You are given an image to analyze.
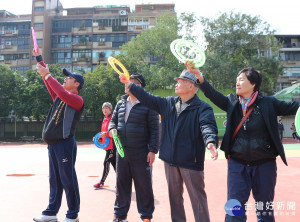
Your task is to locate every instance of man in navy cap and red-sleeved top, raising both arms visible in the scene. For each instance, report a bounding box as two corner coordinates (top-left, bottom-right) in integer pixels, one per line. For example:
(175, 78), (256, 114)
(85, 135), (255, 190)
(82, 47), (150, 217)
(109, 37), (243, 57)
(33, 50), (84, 222)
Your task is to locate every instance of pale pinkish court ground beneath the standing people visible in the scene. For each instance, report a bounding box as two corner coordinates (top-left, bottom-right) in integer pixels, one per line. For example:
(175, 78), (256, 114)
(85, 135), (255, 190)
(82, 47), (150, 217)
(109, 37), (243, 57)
(0, 140), (300, 222)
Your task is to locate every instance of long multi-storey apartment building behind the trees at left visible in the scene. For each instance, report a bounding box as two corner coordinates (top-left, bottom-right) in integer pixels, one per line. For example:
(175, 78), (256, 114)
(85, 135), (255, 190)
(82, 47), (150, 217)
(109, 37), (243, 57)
(0, 0), (176, 73)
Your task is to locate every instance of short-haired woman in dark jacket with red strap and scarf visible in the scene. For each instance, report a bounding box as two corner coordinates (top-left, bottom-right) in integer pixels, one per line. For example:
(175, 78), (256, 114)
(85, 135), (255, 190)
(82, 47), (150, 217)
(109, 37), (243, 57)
(185, 62), (299, 222)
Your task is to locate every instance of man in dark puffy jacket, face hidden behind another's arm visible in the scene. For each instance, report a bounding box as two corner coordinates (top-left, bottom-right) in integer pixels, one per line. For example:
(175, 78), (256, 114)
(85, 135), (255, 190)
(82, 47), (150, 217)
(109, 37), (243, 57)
(108, 74), (159, 222)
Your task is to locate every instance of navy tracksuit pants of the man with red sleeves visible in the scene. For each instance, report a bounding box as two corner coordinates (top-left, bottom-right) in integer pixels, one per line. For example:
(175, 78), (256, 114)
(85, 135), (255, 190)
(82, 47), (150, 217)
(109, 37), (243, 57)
(42, 137), (80, 219)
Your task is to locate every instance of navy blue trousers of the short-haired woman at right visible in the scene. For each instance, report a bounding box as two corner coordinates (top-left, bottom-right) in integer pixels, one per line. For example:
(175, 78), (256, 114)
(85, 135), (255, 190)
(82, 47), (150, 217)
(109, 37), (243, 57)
(225, 159), (277, 222)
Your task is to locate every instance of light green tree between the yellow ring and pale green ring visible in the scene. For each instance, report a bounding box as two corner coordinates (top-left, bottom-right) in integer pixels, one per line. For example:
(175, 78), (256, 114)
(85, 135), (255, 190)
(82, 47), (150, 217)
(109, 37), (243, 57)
(121, 13), (184, 90)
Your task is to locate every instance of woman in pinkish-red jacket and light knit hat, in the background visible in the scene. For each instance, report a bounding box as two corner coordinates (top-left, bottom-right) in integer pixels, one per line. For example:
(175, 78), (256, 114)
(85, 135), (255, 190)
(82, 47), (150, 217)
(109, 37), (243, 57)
(94, 102), (116, 189)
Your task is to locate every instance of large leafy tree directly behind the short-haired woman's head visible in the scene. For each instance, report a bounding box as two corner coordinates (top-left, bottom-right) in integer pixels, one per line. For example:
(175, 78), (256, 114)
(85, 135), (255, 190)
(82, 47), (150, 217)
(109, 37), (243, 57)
(200, 11), (282, 93)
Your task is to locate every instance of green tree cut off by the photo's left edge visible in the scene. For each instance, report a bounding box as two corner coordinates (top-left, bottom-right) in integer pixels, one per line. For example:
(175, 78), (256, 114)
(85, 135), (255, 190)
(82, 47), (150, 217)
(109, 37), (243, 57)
(0, 65), (16, 117)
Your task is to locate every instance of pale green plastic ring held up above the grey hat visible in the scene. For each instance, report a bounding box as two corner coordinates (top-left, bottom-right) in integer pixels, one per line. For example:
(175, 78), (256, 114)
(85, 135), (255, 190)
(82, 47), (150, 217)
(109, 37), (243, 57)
(170, 39), (206, 68)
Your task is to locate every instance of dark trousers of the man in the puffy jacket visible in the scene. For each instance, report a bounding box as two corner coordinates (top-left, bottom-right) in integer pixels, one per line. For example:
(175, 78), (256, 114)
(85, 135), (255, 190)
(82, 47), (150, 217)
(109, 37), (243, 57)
(114, 147), (154, 219)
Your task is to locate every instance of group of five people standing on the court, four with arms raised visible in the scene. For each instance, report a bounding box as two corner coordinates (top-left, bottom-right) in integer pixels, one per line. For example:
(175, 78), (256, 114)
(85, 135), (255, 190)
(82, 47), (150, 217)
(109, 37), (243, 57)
(34, 48), (299, 222)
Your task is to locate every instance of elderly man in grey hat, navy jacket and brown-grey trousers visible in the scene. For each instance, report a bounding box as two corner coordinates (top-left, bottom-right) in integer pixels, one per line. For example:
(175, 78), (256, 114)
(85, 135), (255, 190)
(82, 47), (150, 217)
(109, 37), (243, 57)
(120, 70), (218, 222)
